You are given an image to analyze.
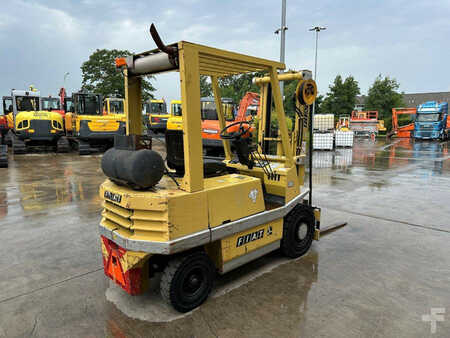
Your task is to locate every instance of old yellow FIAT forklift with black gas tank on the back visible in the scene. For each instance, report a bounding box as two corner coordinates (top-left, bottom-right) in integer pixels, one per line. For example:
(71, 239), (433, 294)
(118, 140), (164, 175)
(99, 25), (320, 312)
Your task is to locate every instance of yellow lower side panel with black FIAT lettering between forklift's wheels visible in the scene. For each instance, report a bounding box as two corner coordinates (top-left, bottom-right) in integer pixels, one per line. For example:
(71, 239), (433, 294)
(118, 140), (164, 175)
(220, 218), (283, 263)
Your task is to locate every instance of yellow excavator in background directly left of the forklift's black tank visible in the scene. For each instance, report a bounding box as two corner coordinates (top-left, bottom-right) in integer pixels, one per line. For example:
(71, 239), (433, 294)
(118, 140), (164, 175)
(65, 92), (125, 155)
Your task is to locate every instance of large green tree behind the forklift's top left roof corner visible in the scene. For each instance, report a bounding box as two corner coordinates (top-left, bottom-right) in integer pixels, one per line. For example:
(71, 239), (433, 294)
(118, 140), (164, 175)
(81, 49), (155, 101)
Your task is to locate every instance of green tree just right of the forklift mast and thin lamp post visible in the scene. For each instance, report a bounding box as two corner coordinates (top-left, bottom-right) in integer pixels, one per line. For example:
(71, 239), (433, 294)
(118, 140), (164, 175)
(320, 75), (360, 115)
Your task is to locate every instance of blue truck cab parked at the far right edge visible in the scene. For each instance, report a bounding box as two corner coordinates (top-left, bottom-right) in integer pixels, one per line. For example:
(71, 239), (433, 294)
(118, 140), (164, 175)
(414, 101), (448, 140)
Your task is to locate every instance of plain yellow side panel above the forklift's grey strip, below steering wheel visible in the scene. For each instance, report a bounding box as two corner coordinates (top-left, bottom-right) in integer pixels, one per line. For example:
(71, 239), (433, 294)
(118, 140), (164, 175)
(205, 174), (265, 227)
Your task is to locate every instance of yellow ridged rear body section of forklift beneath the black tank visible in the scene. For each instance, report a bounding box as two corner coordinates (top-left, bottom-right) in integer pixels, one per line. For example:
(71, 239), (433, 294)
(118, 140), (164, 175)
(100, 177), (208, 242)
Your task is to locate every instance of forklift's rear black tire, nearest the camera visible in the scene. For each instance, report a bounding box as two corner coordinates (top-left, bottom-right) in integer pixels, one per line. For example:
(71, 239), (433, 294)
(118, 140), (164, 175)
(160, 251), (215, 312)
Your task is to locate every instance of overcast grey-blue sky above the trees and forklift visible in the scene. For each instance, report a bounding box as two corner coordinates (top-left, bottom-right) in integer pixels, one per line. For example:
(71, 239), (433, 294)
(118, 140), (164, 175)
(0, 0), (450, 109)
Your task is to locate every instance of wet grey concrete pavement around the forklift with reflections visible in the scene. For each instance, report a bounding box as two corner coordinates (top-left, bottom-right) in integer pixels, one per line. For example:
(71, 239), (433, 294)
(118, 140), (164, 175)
(0, 140), (450, 337)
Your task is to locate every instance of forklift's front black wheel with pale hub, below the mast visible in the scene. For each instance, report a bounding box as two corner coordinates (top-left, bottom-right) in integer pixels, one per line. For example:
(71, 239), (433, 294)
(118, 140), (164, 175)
(281, 204), (315, 258)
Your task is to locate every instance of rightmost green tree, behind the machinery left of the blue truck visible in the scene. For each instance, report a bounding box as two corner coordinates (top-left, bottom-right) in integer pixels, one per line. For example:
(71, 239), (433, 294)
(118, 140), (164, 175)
(365, 74), (404, 129)
